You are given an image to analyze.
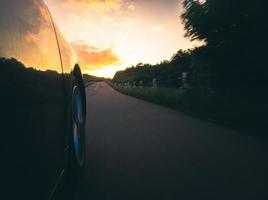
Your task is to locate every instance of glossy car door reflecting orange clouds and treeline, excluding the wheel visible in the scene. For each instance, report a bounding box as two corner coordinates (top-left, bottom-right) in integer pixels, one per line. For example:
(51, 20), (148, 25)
(0, 0), (66, 199)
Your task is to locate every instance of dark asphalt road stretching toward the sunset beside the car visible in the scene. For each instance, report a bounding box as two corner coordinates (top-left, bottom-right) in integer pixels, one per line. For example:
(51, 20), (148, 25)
(75, 83), (268, 200)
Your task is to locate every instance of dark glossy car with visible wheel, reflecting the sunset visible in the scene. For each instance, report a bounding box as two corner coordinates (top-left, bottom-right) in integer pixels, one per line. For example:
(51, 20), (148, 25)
(0, 0), (86, 200)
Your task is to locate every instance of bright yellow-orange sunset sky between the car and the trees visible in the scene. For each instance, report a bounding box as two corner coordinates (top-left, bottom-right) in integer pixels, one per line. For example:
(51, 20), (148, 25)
(45, 0), (197, 78)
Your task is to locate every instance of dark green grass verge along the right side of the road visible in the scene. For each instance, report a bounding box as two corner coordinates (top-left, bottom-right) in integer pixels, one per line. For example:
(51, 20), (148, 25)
(114, 84), (264, 134)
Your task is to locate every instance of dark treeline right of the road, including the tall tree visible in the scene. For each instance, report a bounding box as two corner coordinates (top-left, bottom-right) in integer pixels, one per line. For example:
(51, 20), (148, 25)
(113, 0), (268, 133)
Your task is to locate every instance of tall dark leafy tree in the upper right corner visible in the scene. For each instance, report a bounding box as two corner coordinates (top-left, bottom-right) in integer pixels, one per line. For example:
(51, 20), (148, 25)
(182, 0), (268, 93)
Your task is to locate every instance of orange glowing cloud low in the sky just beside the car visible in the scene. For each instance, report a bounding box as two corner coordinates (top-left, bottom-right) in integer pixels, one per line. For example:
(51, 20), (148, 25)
(72, 41), (121, 70)
